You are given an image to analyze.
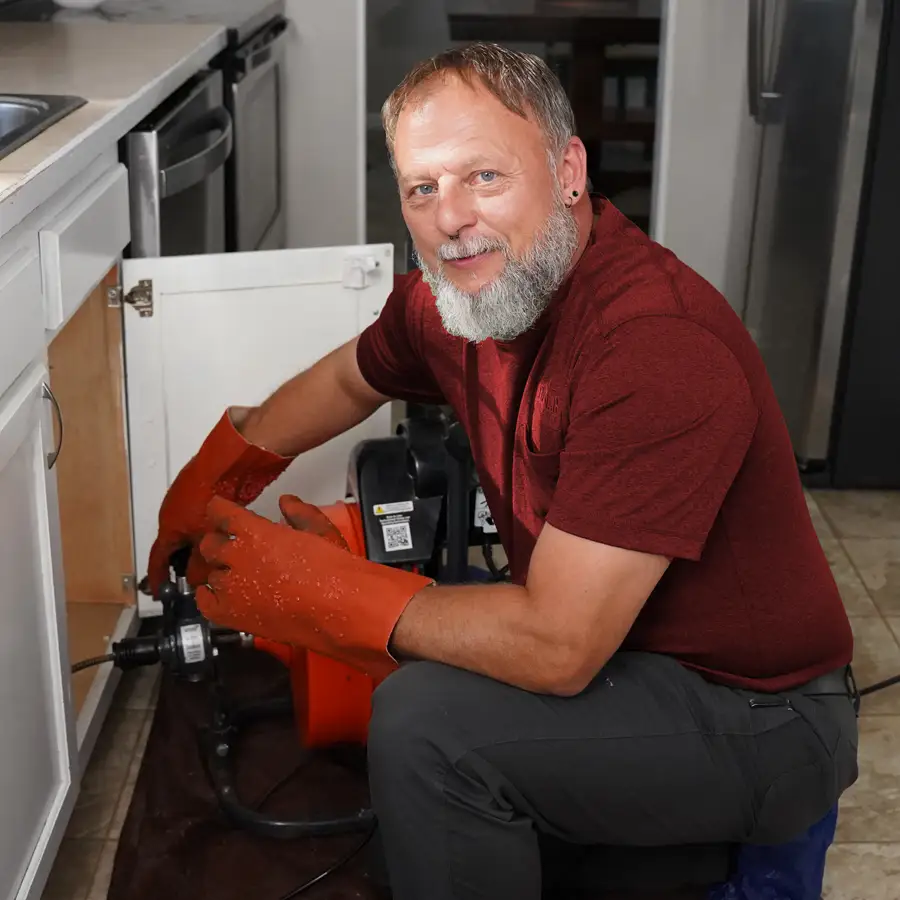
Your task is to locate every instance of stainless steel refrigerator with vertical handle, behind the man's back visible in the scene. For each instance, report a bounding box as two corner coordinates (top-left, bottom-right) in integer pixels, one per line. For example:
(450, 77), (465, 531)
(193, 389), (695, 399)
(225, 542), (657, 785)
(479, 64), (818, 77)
(741, 0), (885, 468)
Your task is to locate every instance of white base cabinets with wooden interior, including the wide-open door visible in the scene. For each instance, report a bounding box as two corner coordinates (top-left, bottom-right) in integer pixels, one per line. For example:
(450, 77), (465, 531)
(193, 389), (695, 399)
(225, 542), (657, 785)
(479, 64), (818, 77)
(0, 174), (394, 900)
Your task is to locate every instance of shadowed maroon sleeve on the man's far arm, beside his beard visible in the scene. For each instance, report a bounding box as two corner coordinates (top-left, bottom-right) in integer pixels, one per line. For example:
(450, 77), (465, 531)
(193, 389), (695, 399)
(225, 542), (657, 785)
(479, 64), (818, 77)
(356, 270), (446, 404)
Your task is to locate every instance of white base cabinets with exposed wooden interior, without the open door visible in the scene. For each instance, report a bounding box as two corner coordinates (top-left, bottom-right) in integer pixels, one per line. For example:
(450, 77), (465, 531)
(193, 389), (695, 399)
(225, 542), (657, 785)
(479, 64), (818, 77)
(0, 153), (137, 900)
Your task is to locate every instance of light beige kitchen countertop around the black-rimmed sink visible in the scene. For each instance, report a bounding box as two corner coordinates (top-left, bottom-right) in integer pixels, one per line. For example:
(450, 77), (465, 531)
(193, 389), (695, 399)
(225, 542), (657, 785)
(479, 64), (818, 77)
(0, 22), (226, 236)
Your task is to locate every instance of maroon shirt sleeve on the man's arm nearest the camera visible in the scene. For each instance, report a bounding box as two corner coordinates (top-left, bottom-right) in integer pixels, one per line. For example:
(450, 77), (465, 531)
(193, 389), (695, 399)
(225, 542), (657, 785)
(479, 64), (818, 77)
(546, 317), (757, 560)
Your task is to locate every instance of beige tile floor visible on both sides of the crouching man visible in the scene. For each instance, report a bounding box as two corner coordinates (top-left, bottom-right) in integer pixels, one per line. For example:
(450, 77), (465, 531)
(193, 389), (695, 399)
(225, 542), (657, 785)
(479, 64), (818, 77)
(44, 491), (900, 900)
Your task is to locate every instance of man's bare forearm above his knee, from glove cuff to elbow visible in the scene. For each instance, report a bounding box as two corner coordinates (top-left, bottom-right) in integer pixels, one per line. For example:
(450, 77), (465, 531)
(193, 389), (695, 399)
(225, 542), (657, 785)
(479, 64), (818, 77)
(390, 584), (592, 694)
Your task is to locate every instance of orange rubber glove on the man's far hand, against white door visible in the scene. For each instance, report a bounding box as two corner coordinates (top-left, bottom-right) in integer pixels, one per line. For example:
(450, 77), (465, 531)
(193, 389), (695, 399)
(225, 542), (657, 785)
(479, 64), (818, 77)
(147, 410), (293, 595)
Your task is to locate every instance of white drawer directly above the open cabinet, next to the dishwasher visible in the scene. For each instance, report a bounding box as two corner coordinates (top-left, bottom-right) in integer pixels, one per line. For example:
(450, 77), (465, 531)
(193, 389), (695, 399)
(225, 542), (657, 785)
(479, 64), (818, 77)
(39, 165), (131, 331)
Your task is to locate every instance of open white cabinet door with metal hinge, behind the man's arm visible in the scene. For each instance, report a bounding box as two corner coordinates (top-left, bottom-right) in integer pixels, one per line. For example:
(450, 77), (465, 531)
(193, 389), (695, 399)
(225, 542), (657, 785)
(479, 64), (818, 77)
(122, 244), (394, 616)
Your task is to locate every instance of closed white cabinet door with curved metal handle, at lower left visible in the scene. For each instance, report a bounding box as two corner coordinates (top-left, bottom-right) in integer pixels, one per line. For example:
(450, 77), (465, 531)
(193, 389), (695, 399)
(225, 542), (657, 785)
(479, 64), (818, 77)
(0, 365), (75, 900)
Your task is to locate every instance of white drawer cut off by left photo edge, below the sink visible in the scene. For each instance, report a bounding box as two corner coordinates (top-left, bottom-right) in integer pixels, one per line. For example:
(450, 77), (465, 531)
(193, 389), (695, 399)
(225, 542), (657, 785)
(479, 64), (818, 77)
(0, 243), (44, 396)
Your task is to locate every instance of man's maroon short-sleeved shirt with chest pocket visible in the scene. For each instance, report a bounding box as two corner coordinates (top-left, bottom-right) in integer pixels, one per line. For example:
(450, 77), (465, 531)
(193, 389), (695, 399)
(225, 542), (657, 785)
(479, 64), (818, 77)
(358, 200), (852, 690)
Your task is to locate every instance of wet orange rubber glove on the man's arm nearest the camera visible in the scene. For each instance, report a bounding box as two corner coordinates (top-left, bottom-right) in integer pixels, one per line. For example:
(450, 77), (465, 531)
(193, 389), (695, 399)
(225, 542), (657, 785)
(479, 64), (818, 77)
(196, 497), (433, 678)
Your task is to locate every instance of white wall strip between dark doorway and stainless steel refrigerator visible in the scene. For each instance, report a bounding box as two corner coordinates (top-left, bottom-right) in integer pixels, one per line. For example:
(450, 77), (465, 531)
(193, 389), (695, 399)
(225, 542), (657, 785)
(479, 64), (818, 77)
(652, 0), (760, 312)
